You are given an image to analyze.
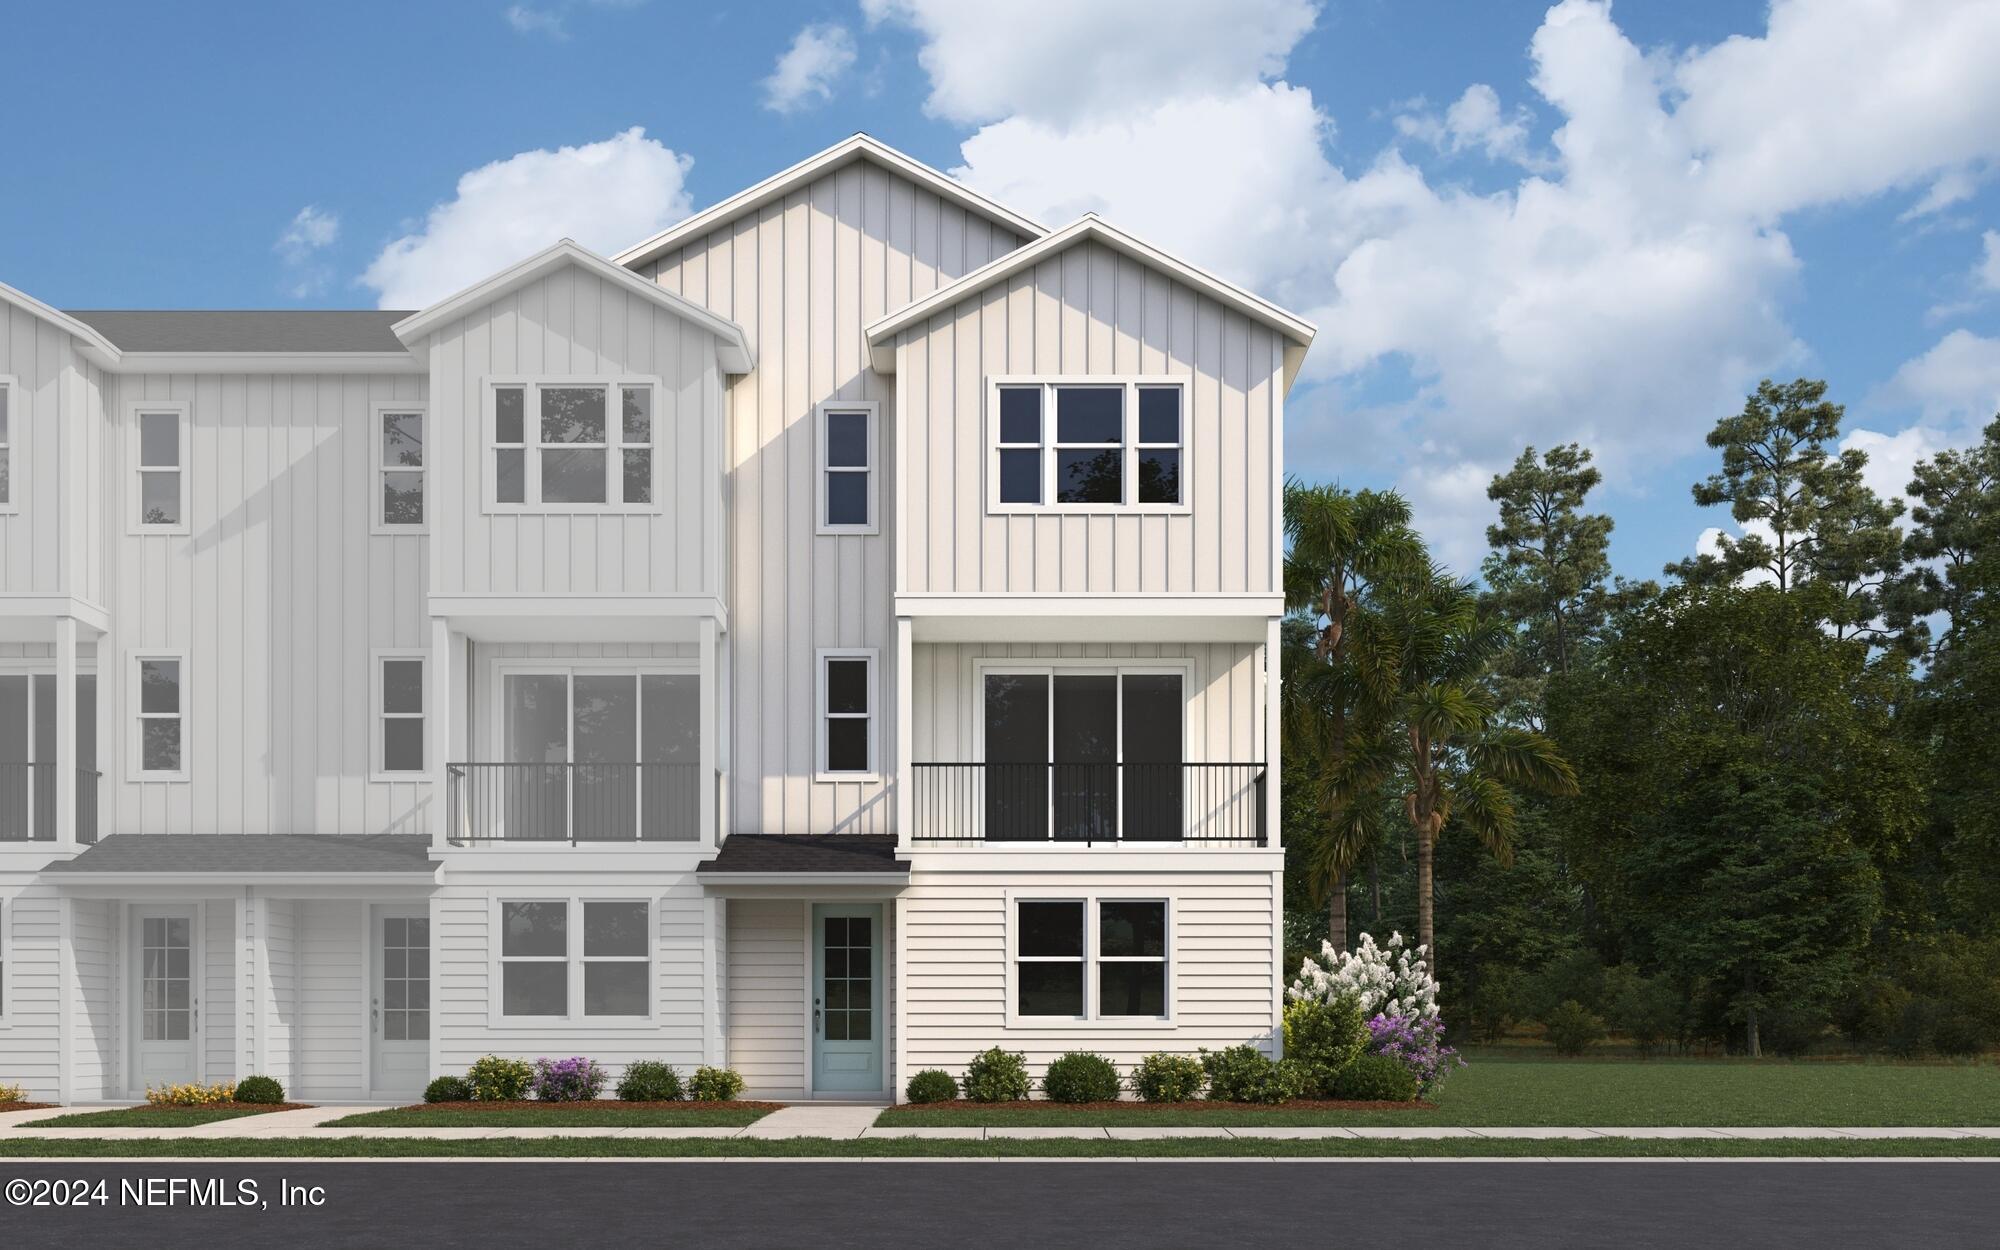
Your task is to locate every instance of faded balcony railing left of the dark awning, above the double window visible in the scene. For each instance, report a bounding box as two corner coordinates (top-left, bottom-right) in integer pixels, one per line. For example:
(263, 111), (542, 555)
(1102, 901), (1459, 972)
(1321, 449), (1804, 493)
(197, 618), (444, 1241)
(444, 764), (702, 844)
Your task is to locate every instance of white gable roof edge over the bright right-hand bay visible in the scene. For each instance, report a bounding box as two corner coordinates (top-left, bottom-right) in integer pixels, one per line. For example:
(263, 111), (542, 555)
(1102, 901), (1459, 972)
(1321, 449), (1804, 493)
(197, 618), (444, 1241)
(866, 212), (1318, 390)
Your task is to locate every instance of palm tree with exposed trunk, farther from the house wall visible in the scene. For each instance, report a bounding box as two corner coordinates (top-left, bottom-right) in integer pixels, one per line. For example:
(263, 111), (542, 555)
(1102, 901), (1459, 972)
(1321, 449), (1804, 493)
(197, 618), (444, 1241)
(1370, 568), (1576, 972)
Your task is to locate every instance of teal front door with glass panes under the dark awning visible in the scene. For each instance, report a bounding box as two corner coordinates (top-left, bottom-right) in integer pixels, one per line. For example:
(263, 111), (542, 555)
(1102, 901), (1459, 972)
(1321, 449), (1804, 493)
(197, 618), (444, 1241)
(812, 902), (886, 1094)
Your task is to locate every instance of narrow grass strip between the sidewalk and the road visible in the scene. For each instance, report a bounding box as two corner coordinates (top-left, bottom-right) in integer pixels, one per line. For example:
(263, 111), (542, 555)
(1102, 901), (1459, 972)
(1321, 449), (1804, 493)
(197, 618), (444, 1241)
(0, 1136), (2000, 1158)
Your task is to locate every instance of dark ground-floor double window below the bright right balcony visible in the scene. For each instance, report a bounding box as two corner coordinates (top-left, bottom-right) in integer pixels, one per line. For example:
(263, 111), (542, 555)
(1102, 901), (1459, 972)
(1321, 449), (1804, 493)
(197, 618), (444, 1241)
(1014, 898), (1168, 1020)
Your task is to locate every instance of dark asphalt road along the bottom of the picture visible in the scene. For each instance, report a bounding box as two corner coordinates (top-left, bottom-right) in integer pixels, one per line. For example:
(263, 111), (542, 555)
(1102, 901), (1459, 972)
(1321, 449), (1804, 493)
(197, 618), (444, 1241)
(0, 1160), (2000, 1250)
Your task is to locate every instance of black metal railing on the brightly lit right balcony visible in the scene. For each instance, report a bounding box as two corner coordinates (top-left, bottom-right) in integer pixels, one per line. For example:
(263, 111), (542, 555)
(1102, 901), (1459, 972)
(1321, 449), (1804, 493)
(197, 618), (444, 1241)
(910, 764), (1266, 846)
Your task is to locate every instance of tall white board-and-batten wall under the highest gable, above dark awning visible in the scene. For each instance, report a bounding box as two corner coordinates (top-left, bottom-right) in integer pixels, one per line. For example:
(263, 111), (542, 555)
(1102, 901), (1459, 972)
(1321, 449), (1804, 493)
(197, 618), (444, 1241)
(640, 162), (1022, 834)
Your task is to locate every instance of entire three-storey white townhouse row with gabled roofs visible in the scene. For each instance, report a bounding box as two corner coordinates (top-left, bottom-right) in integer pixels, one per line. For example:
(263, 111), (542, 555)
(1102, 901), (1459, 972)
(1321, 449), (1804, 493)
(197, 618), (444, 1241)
(0, 136), (1312, 1102)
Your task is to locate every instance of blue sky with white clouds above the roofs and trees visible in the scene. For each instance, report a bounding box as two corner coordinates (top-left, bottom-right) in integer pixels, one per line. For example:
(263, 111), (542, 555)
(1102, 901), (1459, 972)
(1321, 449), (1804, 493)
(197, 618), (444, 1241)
(0, 0), (2000, 576)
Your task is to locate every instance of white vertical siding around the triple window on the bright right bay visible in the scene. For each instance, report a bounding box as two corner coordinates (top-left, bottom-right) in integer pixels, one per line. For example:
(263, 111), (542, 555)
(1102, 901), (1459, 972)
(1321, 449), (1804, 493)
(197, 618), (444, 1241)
(898, 242), (1282, 594)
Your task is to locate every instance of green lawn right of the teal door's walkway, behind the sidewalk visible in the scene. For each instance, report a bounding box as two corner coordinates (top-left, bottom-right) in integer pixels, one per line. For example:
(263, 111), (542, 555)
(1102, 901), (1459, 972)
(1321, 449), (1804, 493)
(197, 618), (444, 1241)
(878, 1058), (2000, 1128)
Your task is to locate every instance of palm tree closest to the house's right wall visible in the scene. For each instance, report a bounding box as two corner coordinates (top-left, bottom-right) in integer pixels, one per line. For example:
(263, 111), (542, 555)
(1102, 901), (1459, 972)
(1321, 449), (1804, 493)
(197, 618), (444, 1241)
(1284, 478), (1428, 950)
